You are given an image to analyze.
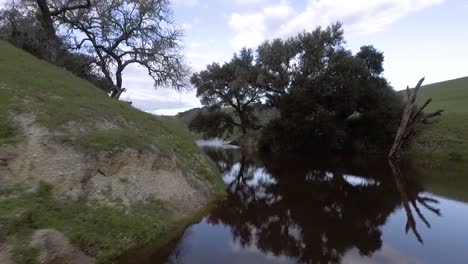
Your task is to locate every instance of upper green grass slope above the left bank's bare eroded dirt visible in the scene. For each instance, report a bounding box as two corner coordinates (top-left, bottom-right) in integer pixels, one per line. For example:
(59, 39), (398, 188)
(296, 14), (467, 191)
(0, 42), (220, 188)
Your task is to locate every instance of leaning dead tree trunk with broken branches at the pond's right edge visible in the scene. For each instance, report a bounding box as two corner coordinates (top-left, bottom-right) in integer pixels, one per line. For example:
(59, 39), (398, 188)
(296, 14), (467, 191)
(388, 78), (444, 159)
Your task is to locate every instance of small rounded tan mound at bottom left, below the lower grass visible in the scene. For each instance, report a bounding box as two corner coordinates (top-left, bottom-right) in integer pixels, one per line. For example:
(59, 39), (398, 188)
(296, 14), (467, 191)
(31, 229), (96, 264)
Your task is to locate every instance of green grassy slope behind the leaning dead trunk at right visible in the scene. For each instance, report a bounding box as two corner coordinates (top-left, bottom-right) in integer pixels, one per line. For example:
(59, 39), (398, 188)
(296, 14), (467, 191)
(409, 77), (468, 163)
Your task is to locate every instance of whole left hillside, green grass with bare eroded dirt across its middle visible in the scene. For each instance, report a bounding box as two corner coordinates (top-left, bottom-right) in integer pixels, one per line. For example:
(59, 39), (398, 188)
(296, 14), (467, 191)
(0, 41), (224, 263)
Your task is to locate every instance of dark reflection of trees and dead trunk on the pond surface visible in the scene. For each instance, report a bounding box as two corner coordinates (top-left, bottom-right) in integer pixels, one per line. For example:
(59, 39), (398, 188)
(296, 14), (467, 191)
(203, 151), (440, 263)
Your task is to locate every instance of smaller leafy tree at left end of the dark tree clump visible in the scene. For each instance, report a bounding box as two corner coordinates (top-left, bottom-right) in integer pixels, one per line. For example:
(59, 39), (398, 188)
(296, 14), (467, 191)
(190, 48), (264, 134)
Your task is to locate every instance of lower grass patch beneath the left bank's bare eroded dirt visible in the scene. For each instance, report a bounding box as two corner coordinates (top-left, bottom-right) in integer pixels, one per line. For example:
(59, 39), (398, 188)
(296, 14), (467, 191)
(0, 183), (174, 263)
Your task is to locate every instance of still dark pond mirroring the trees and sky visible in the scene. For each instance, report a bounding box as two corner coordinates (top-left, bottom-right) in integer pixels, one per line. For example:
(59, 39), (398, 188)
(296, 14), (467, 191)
(127, 148), (468, 264)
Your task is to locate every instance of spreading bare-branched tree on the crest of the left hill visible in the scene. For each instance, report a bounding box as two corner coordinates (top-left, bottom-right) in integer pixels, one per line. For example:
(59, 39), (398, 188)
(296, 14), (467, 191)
(58, 0), (189, 99)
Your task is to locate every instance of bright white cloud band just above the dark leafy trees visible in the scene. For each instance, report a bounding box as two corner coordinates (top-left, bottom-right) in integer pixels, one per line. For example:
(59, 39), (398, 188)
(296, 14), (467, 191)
(229, 0), (445, 48)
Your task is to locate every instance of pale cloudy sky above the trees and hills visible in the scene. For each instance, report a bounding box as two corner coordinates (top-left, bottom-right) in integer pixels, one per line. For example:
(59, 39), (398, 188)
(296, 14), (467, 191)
(0, 0), (468, 115)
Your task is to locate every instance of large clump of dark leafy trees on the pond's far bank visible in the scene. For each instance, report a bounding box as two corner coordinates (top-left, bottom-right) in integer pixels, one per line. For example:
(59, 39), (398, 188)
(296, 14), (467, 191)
(191, 23), (402, 155)
